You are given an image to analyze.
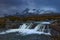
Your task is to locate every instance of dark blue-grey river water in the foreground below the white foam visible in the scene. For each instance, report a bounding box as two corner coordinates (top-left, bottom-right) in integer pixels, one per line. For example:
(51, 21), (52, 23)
(0, 32), (51, 40)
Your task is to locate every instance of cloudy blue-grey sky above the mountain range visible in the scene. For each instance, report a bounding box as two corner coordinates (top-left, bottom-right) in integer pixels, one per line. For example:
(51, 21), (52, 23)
(0, 0), (60, 16)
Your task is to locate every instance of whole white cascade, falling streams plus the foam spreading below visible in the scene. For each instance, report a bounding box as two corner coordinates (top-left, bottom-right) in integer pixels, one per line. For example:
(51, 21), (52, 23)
(0, 23), (50, 35)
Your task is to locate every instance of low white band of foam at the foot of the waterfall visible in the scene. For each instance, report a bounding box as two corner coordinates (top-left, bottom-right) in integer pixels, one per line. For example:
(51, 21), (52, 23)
(0, 29), (51, 35)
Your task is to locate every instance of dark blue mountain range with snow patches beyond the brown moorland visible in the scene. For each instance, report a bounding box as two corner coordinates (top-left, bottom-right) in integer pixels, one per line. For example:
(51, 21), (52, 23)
(4, 8), (60, 17)
